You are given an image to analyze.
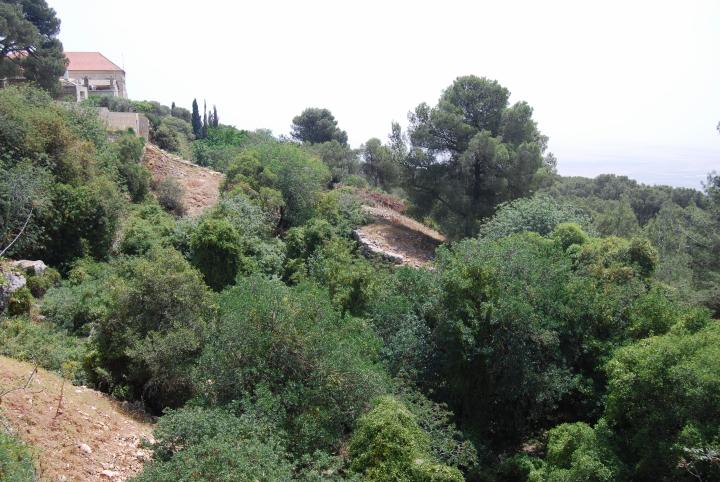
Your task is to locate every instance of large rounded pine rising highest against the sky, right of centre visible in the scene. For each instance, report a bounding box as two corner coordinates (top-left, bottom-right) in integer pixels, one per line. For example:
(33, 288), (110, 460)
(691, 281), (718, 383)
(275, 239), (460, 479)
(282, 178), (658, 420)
(396, 76), (547, 236)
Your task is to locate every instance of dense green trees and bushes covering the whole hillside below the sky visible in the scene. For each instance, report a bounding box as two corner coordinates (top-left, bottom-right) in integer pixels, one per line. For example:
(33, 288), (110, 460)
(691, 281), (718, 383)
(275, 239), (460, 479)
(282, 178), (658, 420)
(0, 7), (720, 474)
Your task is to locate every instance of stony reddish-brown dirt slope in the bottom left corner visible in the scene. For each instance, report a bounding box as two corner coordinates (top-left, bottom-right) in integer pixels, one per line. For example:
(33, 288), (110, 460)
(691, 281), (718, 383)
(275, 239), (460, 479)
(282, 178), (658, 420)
(0, 357), (152, 482)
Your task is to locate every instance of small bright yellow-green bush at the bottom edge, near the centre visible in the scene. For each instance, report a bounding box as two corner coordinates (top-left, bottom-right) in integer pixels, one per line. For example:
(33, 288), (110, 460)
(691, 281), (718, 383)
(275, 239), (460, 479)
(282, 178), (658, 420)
(348, 397), (465, 482)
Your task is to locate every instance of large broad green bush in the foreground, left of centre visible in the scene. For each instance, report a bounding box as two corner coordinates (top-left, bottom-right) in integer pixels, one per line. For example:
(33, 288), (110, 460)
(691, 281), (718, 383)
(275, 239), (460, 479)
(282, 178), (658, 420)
(196, 275), (386, 453)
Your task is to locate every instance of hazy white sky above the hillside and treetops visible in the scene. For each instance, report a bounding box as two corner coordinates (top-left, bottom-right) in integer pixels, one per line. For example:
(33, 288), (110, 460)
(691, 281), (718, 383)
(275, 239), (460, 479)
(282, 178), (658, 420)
(48, 0), (720, 187)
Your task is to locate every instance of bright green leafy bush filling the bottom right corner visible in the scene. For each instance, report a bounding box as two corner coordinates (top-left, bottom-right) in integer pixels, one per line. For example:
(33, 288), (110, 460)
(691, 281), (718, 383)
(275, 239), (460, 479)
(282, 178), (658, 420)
(605, 313), (720, 480)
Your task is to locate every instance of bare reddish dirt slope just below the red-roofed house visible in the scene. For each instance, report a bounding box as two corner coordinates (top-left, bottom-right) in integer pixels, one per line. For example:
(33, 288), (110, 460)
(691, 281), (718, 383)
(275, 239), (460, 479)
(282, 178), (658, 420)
(143, 144), (223, 216)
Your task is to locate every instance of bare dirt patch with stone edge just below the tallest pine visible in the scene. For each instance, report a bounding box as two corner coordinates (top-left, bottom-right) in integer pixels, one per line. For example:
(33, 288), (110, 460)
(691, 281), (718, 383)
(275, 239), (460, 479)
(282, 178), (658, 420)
(355, 204), (445, 268)
